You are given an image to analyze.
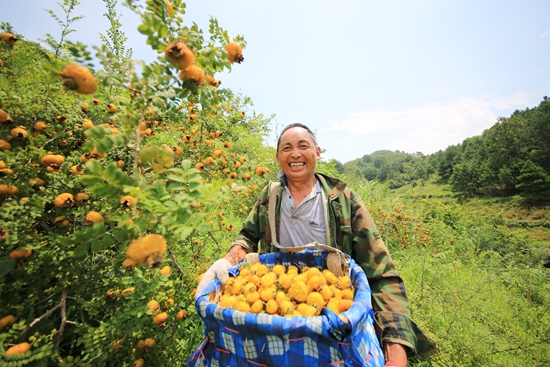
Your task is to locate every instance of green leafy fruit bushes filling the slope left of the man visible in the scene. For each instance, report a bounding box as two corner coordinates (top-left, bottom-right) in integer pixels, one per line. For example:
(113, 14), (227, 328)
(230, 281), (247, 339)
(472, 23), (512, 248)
(0, 1), (275, 366)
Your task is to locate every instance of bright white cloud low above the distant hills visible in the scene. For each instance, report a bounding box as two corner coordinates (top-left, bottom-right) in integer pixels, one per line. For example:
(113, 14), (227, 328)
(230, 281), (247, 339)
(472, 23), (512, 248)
(320, 93), (530, 161)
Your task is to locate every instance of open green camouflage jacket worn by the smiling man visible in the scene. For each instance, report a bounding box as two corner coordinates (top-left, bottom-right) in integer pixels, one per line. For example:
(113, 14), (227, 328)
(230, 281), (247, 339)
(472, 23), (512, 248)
(232, 173), (436, 358)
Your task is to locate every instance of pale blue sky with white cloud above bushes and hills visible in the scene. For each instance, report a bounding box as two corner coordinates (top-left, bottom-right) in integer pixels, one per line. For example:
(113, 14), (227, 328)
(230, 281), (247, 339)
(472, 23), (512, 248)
(0, 0), (550, 163)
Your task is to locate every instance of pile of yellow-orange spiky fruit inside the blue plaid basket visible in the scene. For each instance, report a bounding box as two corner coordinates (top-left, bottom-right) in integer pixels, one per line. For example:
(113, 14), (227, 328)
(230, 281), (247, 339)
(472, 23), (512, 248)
(209, 263), (354, 317)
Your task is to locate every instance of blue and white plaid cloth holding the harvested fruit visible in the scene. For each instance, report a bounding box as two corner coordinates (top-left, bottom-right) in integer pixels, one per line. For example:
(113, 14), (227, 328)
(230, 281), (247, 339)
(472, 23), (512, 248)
(186, 250), (384, 367)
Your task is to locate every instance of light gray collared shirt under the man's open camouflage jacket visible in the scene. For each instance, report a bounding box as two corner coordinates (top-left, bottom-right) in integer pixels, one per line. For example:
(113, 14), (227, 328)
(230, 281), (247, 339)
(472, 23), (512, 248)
(279, 180), (326, 247)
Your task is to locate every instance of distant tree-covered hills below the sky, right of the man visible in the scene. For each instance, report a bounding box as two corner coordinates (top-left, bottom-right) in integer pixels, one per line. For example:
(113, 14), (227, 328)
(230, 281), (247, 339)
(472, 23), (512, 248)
(335, 97), (550, 202)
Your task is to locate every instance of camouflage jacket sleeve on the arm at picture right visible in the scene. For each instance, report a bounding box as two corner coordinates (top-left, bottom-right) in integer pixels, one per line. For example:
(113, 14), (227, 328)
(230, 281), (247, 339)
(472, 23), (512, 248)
(350, 196), (435, 358)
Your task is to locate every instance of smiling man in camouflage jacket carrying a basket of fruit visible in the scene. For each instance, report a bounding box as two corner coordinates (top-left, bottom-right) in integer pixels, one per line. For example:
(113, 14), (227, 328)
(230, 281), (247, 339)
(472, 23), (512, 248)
(196, 124), (435, 367)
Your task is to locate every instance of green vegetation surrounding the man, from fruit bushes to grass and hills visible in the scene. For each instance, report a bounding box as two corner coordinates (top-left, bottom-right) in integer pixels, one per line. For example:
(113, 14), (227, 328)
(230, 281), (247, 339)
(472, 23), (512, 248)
(0, 0), (550, 366)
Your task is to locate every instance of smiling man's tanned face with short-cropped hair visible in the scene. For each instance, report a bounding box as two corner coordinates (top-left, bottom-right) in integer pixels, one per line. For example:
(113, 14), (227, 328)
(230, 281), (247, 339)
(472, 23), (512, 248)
(277, 127), (321, 181)
